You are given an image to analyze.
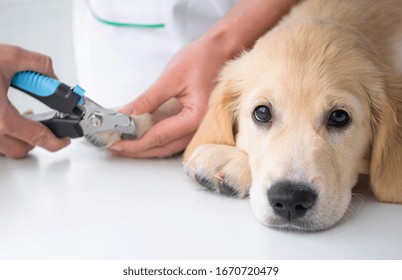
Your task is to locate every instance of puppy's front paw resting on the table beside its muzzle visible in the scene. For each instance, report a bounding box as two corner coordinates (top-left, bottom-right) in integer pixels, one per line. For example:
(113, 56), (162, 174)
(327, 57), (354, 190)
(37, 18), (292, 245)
(184, 144), (251, 197)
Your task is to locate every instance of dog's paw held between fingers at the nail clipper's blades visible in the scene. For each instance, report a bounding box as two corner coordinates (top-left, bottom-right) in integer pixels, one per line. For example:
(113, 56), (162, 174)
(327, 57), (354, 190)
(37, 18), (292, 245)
(86, 114), (154, 148)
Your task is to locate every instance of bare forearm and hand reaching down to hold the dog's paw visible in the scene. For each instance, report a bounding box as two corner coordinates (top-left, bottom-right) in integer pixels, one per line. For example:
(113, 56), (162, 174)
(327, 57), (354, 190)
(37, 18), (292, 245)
(111, 0), (298, 158)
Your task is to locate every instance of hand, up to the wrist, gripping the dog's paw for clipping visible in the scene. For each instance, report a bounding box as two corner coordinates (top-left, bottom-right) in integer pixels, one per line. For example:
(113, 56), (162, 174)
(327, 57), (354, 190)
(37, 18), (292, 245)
(111, 34), (232, 158)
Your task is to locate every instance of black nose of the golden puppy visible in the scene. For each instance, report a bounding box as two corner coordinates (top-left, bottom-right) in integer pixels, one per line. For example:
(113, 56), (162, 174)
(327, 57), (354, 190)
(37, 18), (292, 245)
(268, 181), (317, 221)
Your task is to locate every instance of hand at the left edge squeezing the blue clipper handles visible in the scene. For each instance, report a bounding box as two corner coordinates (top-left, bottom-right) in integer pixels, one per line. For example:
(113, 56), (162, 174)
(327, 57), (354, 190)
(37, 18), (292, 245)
(0, 44), (70, 158)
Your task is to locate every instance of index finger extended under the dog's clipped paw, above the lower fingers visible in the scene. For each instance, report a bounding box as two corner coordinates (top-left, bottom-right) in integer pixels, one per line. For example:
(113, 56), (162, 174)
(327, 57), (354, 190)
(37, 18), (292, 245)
(110, 106), (201, 153)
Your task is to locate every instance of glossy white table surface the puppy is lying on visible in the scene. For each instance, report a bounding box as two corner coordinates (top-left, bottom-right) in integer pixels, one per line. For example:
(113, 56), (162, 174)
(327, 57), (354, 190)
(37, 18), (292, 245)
(0, 140), (402, 259)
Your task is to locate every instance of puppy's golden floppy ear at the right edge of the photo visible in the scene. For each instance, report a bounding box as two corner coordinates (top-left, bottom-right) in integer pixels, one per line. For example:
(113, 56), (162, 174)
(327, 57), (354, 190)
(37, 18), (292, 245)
(370, 74), (402, 203)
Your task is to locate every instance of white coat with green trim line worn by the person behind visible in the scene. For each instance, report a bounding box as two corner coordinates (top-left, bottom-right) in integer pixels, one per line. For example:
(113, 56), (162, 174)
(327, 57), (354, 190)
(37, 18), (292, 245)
(73, 0), (237, 107)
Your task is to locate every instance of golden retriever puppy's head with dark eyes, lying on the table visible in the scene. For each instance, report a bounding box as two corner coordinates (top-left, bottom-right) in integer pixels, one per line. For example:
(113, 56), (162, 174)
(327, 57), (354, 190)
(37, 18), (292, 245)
(192, 21), (402, 230)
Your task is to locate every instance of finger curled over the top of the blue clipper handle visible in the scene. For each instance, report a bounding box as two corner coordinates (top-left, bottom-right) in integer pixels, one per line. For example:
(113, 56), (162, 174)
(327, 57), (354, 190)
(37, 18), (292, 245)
(5, 46), (55, 80)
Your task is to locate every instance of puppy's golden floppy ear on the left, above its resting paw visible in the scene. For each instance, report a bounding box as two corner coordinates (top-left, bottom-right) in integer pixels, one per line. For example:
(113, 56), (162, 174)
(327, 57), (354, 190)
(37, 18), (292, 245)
(184, 71), (240, 161)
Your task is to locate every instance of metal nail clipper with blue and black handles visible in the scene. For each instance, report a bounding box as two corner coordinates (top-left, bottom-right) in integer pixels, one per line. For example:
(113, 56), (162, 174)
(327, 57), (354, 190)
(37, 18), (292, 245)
(11, 71), (136, 146)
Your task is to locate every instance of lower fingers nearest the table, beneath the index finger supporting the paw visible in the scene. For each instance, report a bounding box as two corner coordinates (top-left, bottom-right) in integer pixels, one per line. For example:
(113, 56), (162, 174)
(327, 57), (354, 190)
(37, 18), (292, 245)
(112, 134), (193, 158)
